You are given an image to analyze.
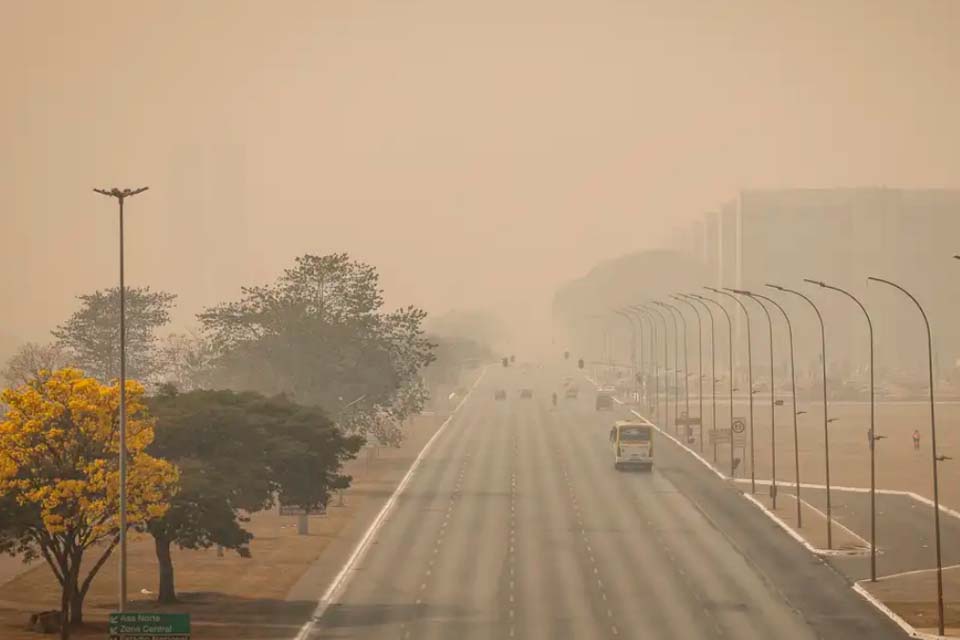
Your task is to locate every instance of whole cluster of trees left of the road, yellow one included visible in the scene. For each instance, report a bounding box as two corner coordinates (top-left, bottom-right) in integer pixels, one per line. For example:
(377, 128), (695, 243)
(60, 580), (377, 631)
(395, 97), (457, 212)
(0, 254), (480, 638)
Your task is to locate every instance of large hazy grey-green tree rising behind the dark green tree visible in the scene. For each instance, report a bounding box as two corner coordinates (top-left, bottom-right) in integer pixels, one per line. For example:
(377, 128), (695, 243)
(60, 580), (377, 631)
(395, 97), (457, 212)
(198, 254), (433, 430)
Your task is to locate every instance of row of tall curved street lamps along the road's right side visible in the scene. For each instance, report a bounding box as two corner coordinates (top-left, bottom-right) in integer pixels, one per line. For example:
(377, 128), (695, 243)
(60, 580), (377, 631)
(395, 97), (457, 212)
(615, 255), (960, 635)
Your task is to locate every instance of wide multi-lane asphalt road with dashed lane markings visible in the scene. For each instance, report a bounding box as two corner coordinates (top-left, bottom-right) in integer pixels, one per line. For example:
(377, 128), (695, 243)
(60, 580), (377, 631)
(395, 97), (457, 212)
(310, 368), (906, 640)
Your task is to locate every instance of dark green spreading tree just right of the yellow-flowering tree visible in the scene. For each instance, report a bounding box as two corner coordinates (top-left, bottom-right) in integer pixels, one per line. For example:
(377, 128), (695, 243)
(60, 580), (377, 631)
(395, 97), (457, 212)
(146, 387), (361, 603)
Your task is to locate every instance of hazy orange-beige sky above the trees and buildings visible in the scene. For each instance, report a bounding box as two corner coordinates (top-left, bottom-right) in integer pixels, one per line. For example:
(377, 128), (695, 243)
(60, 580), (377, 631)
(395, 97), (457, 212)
(0, 0), (960, 350)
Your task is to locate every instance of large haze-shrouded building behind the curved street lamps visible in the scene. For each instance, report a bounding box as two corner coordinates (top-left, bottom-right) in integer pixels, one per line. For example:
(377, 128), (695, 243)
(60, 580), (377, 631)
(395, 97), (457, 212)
(688, 188), (960, 380)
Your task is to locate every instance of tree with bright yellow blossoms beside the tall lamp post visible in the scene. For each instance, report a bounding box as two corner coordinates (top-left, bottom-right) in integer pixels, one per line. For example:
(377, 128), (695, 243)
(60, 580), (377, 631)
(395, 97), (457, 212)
(0, 369), (178, 638)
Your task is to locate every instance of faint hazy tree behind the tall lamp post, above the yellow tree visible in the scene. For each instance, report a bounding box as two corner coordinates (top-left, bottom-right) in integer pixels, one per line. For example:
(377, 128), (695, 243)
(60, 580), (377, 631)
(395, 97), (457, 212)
(52, 287), (176, 382)
